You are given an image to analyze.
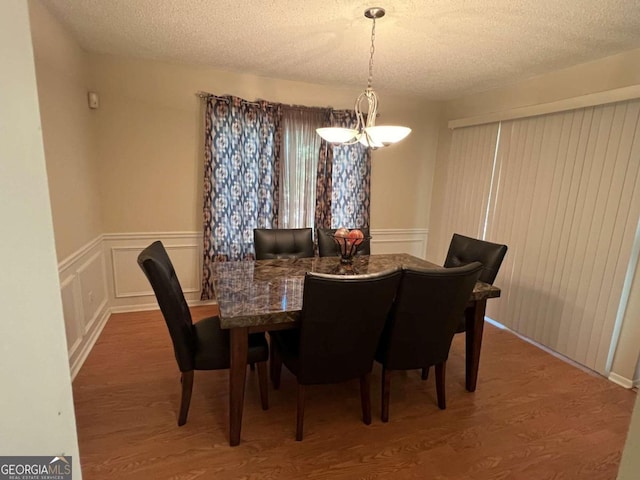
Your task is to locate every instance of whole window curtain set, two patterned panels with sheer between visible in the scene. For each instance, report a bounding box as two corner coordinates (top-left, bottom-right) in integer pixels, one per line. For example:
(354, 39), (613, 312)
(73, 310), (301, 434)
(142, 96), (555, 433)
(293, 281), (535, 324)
(201, 95), (371, 300)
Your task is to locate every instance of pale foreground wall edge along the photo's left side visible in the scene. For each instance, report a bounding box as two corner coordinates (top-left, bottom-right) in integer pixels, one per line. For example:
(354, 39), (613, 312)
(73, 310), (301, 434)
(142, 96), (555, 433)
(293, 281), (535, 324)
(0, 1), (82, 472)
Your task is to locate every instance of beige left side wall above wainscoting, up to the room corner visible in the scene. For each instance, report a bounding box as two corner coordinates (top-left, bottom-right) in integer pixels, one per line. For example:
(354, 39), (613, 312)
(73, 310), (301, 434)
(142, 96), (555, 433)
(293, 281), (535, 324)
(29, 2), (102, 260)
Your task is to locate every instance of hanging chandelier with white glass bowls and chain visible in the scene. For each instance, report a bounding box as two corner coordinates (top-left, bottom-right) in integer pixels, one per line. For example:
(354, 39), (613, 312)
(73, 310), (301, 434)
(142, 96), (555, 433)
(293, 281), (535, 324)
(316, 7), (411, 149)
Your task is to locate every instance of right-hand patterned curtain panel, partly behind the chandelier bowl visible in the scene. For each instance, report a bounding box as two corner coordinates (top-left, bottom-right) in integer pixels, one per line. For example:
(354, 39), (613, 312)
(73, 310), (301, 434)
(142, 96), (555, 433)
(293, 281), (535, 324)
(328, 110), (371, 228)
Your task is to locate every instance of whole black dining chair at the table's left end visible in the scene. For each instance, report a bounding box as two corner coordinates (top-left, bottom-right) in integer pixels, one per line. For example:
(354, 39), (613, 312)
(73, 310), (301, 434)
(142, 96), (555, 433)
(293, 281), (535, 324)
(138, 241), (269, 426)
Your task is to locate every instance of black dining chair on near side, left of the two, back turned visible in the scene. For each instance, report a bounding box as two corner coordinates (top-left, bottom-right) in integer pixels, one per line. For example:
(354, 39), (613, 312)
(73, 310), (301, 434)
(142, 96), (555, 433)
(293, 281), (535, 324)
(270, 269), (401, 441)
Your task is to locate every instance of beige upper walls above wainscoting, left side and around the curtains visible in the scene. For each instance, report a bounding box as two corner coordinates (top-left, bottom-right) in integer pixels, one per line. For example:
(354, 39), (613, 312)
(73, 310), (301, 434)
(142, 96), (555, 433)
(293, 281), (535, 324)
(29, 2), (440, 260)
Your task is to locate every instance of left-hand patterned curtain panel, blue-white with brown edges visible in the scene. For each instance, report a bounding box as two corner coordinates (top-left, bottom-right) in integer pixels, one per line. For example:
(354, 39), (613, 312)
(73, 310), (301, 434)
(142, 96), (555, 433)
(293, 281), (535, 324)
(202, 96), (281, 300)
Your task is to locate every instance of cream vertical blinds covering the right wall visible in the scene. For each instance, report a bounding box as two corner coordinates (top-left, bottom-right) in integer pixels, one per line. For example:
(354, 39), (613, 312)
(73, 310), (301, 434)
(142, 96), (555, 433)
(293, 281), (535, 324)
(445, 100), (640, 374)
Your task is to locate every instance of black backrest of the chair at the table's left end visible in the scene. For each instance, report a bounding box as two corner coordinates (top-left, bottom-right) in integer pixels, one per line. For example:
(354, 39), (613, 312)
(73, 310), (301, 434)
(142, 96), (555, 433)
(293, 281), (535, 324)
(138, 241), (196, 372)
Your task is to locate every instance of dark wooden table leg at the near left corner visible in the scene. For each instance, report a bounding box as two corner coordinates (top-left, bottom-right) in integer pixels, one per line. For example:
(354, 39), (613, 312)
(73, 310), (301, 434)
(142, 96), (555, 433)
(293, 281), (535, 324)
(229, 328), (249, 447)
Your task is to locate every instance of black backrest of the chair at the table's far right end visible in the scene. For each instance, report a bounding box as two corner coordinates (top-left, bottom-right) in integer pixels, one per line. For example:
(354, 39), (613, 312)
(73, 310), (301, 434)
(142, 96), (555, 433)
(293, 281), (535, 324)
(444, 233), (507, 284)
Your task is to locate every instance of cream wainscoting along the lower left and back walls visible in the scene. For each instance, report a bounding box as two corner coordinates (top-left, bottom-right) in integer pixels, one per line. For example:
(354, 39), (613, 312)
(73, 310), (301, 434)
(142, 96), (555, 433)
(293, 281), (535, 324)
(58, 229), (428, 378)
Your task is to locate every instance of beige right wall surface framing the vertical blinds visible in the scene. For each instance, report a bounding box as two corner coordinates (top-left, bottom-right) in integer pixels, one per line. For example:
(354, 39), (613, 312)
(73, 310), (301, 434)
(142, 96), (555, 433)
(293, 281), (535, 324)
(427, 49), (640, 380)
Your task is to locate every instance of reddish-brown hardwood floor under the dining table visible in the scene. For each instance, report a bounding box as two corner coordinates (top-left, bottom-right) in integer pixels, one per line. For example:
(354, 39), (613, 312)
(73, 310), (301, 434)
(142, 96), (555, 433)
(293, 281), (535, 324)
(73, 307), (635, 480)
